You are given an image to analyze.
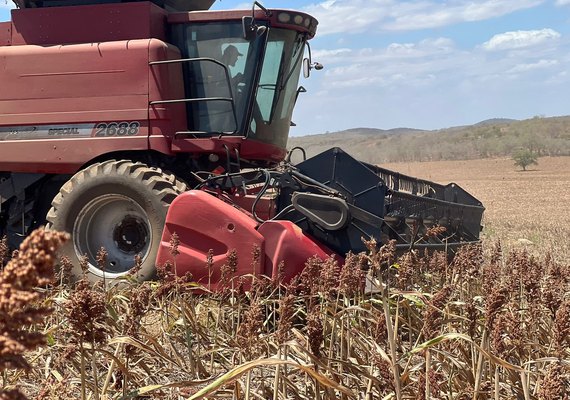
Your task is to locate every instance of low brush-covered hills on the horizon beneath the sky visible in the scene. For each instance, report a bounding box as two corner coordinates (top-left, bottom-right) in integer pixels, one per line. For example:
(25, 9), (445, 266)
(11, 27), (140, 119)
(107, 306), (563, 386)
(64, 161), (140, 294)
(288, 116), (570, 163)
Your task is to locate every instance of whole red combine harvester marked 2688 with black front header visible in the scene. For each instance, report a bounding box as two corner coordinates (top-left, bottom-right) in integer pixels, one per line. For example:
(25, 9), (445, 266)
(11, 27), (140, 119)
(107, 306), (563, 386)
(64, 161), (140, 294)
(0, 0), (484, 288)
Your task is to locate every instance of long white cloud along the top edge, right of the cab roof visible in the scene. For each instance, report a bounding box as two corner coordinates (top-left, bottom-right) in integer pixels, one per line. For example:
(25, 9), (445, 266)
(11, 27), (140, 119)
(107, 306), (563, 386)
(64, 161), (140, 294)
(305, 0), (544, 35)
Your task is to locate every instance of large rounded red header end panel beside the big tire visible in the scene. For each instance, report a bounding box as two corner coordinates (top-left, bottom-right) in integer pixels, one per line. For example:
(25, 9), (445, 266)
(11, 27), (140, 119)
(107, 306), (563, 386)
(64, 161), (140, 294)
(156, 190), (265, 290)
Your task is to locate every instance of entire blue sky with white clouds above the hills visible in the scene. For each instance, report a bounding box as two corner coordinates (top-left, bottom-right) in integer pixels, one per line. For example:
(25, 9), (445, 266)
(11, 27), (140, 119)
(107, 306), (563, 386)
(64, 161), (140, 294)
(0, 0), (570, 135)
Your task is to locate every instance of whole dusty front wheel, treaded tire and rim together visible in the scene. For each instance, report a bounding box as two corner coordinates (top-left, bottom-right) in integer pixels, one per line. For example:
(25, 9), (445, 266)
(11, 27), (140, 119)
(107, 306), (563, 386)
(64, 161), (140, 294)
(47, 160), (186, 281)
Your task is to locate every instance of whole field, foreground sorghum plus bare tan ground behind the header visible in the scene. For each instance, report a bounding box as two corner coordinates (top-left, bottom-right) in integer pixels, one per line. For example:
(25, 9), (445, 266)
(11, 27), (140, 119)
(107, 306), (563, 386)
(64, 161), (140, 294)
(0, 157), (570, 400)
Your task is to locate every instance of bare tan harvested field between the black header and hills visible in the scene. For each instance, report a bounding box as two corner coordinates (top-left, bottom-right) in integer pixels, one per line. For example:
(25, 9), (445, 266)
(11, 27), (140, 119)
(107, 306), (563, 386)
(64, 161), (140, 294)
(382, 157), (570, 262)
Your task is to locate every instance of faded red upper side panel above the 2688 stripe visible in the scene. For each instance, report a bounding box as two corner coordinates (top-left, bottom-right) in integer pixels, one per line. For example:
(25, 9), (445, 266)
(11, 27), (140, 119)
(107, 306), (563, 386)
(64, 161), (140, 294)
(0, 40), (149, 125)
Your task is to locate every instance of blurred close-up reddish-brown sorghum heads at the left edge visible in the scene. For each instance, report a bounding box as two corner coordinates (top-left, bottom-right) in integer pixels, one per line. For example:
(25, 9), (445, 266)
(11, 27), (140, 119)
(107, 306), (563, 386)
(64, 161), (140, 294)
(0, 229), (69, 399)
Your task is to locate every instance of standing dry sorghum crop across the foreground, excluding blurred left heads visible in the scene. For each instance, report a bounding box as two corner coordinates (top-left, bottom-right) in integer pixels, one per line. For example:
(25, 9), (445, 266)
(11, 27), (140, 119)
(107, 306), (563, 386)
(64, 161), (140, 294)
(0, 231), (570, 400)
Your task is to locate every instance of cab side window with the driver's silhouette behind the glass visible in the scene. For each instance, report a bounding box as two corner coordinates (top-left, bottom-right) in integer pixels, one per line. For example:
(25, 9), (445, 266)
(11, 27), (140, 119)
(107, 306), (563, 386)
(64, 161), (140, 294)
(172, 21), (263, 133)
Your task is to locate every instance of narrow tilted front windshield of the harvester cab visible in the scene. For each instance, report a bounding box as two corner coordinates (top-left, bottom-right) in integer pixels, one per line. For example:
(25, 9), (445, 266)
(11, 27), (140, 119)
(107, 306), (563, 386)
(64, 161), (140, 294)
(249, 29), (305, 148)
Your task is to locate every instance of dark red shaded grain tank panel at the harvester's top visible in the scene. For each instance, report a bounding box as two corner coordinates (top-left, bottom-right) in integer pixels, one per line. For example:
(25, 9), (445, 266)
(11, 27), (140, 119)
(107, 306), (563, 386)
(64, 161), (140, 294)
(12, 2), (167, 46)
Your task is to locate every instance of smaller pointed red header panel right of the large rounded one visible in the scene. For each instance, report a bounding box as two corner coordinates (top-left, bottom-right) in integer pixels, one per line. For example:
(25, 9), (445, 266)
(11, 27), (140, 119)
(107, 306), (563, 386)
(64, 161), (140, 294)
(258, 221), (335, 282)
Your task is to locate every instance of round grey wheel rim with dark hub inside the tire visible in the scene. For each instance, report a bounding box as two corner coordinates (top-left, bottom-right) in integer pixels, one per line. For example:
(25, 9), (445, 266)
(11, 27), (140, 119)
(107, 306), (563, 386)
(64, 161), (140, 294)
(73, 194), (152, 278)
